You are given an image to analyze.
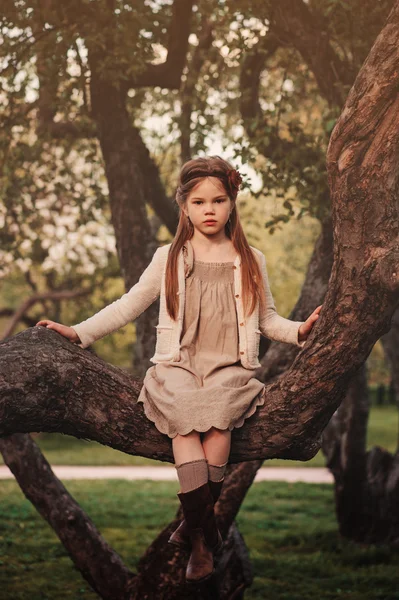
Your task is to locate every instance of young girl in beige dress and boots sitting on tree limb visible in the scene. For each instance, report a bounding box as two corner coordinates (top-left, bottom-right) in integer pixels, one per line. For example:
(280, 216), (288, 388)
(37, 156), (321, 582)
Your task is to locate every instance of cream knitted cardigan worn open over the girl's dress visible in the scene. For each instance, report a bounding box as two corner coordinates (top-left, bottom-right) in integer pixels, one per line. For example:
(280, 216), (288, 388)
(72, 240), (305, 369)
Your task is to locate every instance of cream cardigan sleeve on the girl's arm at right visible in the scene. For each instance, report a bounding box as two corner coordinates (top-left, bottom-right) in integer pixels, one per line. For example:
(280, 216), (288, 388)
(259, 252), (306, 348)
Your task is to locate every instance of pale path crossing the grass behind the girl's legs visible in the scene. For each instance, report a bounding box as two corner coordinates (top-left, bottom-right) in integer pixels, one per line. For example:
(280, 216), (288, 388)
(0, 465), (333, 483)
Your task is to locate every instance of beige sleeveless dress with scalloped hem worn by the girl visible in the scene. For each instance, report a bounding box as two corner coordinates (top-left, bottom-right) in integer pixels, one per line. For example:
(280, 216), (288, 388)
(137, 260), (265, 438)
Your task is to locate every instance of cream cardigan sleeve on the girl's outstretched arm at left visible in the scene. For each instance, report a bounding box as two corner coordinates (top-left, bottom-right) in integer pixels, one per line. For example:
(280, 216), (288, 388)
(71, 246), (162, 348)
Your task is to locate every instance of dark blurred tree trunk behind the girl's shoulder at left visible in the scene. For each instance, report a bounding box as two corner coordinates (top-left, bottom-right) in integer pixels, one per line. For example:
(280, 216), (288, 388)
(89, 51), (158, 377)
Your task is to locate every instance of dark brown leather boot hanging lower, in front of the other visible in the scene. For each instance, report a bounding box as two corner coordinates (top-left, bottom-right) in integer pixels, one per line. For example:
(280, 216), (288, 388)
(178, 482), (223, 583)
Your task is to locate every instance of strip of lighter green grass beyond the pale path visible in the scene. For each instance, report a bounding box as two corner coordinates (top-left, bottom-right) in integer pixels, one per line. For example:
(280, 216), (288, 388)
(0, 406), (398, 467)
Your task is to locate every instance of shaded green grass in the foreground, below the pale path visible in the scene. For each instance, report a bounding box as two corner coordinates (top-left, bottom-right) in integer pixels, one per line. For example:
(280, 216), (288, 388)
(0, 480), (399, 600)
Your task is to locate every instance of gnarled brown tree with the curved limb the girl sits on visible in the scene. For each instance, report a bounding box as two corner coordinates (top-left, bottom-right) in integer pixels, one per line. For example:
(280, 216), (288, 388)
(0, 3), (398, 598)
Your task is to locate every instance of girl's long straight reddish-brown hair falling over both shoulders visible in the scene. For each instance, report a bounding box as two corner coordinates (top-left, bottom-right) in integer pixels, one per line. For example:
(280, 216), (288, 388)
(165, 156), (266, 320)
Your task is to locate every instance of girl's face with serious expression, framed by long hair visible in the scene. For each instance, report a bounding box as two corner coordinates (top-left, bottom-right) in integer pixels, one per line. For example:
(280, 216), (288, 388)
(182, 177), (233, 236)
